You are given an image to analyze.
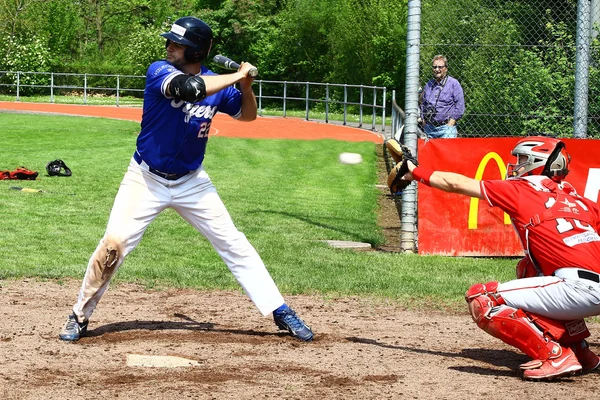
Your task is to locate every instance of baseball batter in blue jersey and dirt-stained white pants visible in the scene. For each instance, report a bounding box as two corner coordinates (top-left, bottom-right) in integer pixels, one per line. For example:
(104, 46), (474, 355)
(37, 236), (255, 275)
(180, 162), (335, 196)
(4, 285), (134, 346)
(59, 17), (313, 341)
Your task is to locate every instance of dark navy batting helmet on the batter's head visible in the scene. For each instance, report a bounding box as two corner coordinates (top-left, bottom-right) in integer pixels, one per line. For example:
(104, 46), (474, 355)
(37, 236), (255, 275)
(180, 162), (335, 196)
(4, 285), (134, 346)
(160, 17), (213, 63)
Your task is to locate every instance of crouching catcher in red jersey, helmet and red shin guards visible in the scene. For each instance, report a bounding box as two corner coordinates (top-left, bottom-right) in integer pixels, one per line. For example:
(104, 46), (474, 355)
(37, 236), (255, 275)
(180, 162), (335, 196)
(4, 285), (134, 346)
(404, 137), (600, 380)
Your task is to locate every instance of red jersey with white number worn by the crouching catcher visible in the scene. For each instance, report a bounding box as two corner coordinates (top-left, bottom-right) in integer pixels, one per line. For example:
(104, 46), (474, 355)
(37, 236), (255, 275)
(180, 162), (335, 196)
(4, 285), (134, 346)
(481, 176), (600, 275)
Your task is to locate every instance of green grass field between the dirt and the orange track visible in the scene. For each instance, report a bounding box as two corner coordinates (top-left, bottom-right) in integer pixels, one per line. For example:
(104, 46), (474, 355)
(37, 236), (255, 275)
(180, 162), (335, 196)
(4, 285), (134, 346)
(0, 113), (515, 307)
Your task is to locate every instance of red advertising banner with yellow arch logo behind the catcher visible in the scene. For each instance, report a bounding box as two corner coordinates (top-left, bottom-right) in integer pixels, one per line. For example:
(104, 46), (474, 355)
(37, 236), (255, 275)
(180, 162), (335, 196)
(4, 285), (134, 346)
(418, 138), (600, 256)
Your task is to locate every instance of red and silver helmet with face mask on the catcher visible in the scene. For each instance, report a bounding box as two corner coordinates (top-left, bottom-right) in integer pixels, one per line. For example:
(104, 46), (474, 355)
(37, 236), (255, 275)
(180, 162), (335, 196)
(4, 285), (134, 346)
(506, 136), (571, 181)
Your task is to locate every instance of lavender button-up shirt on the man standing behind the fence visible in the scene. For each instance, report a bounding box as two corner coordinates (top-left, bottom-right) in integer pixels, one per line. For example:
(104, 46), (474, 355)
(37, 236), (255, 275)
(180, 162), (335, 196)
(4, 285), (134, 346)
(421, 75), (465, 125)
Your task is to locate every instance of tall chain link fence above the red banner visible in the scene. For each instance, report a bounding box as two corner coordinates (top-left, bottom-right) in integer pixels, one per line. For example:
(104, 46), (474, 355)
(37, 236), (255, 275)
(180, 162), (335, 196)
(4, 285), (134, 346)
(418, 0), (600, 138)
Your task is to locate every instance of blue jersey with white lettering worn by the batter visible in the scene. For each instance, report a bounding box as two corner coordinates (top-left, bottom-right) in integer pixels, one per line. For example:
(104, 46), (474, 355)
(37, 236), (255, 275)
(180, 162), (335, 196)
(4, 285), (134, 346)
(137, 60), (242, 174)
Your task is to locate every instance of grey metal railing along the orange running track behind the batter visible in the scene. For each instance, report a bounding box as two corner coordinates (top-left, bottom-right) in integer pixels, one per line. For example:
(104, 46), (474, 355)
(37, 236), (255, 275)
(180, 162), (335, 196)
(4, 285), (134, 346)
(0, 71), (395, 132)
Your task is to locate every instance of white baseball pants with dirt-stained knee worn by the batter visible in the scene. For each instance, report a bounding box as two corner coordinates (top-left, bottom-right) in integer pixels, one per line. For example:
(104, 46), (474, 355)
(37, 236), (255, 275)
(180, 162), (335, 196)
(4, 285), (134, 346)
(73, 158), (284, 321)
